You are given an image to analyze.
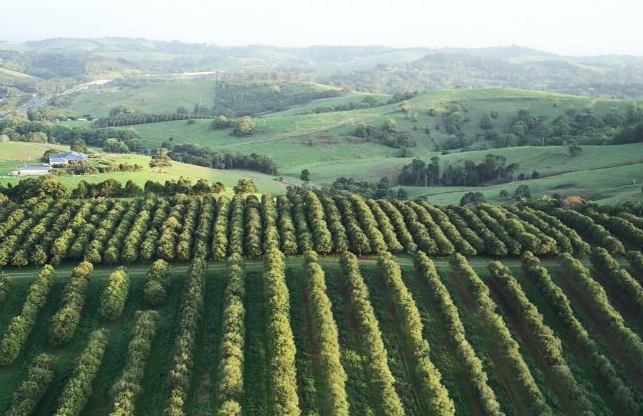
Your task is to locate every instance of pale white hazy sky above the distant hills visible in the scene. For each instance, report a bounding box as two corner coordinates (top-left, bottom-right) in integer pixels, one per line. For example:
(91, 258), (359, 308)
(0, 0), (643, 55)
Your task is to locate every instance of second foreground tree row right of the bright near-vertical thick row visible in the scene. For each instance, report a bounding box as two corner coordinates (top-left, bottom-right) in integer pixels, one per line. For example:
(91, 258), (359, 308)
(339, 253), (404, 415)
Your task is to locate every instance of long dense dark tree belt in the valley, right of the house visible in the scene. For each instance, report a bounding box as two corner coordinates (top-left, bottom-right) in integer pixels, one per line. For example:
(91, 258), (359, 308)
(166, 144), (277, 175)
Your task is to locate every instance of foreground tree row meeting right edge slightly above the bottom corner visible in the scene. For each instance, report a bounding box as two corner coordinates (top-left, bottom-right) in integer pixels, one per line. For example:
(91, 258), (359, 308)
(558, 253), (643, 370)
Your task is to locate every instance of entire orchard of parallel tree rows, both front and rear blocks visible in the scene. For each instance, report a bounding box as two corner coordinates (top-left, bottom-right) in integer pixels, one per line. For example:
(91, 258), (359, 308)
(0, 192), (643, 415)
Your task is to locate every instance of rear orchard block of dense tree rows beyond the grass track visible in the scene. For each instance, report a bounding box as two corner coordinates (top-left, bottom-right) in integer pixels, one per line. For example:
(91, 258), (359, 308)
(0, 193), (638, 266)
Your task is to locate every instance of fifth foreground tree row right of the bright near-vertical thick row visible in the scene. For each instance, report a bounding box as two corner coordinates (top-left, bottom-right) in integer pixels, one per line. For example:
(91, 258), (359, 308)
(450, 254), (553, 415)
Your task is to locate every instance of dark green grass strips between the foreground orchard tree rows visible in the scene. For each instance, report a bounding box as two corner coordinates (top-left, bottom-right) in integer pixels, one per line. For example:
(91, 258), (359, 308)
(0, 256), (643, 416)
